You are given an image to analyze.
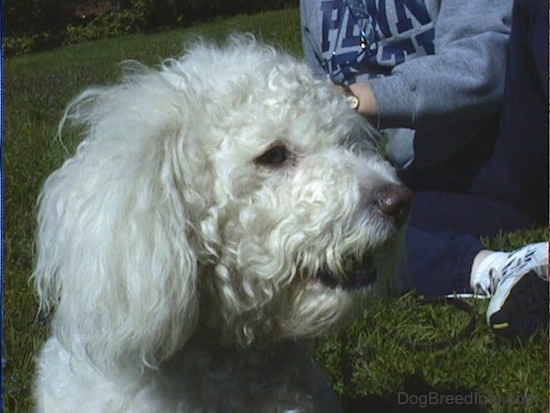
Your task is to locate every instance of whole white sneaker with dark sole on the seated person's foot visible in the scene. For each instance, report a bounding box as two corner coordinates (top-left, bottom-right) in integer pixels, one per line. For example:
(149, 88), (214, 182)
(473, 242), (549, 338)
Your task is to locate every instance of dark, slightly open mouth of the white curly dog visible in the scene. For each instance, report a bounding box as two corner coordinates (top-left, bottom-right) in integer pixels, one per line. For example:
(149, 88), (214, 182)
(317, 255), (376, 290)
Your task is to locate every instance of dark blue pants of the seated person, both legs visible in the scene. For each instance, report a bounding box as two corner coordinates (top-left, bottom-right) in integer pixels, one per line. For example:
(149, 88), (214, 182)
(400, 0), (549, 297)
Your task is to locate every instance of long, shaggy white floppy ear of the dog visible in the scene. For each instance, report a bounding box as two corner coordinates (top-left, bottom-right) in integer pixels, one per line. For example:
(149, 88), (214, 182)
(34, 69), (204, 365)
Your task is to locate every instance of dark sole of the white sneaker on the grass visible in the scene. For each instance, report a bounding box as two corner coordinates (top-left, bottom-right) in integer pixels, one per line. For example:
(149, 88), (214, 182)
(489, 271), (549, 339)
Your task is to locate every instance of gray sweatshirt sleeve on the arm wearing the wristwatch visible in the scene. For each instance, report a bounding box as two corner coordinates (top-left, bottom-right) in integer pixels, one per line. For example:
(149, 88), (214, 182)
(368, 0), (512, 128)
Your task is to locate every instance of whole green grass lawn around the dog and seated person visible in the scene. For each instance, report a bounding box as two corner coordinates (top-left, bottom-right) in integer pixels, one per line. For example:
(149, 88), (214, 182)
(2, 9), (548, 413)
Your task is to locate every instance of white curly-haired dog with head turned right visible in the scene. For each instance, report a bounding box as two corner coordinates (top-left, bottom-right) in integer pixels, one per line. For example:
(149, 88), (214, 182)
(33, 36), (410, 413)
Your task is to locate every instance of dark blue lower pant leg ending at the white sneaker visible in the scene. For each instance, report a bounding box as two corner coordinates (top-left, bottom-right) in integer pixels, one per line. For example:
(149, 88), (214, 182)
(402, 227), (485, 297)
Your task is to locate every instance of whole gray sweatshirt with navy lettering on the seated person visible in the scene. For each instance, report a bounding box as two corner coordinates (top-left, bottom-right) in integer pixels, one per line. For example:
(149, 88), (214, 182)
(300, 0), (513, 167)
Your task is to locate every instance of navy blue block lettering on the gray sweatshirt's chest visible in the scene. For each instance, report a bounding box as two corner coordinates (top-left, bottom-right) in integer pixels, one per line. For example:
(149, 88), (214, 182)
(321, 0), (434, 83)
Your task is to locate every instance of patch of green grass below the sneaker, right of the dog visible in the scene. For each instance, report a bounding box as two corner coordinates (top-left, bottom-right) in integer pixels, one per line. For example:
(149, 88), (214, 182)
(318, 278), (548, 413)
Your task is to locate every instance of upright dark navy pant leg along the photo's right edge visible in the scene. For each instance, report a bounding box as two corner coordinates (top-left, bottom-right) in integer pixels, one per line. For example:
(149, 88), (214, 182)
(471, 0), (549, 224)
